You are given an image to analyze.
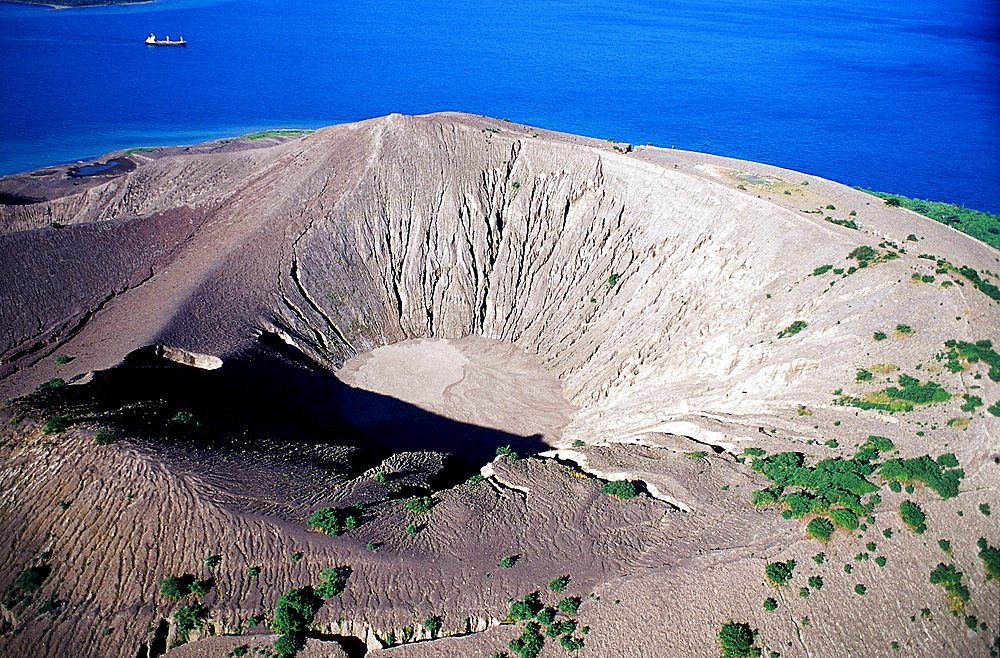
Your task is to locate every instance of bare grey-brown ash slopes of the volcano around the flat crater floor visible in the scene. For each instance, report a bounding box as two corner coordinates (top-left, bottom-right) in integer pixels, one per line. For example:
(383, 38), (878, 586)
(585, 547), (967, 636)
(0, 114), (1000, 656)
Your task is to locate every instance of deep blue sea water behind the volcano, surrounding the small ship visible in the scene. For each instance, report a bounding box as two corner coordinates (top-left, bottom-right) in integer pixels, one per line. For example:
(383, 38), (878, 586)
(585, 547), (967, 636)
(0, 0), (1000, 212)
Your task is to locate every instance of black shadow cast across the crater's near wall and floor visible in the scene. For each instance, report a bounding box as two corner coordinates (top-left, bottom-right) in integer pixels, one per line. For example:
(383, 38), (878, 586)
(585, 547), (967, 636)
(25, 334), (548, 486)
